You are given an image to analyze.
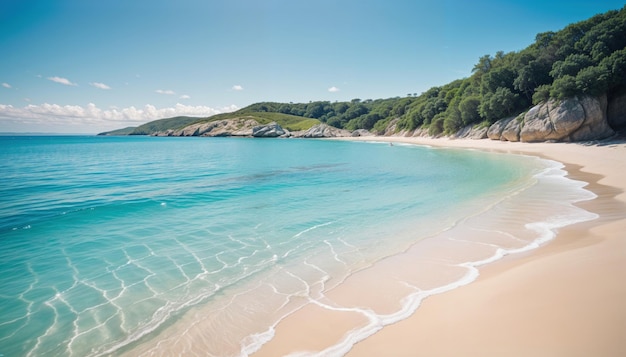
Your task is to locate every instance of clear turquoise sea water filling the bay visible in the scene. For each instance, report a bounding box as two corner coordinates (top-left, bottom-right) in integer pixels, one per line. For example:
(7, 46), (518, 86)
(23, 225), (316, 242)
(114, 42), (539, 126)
(0, 136), (592, 356)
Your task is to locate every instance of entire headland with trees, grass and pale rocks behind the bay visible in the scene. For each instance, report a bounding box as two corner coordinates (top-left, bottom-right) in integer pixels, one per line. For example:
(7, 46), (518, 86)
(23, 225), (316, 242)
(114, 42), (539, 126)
(99, 6), (626, 142)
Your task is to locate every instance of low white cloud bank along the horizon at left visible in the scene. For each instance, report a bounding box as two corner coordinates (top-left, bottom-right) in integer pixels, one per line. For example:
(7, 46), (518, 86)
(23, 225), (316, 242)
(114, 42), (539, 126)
(0, 103), (239, 133)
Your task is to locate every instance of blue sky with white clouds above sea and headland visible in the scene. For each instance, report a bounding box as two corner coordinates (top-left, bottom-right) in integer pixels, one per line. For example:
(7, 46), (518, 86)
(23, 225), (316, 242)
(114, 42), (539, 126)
(0, 0), (624, 133)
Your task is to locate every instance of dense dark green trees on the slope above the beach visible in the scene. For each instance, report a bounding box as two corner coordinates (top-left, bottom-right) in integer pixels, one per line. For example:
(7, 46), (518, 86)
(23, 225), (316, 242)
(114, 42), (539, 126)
(238, 7), (626, 134)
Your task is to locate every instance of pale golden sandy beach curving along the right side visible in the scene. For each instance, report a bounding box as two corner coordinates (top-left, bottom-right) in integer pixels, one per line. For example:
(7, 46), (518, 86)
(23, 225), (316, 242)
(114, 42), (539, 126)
(255, 137), (626, 356)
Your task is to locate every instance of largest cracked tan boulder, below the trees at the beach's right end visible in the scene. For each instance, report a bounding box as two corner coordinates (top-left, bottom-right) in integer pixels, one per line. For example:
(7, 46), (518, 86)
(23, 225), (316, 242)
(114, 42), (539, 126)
(520, 96), (614, 142)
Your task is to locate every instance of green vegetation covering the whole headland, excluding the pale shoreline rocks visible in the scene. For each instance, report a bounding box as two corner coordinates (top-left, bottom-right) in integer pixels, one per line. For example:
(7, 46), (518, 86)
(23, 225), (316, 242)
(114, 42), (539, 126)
(100, 7), (626, 140)
